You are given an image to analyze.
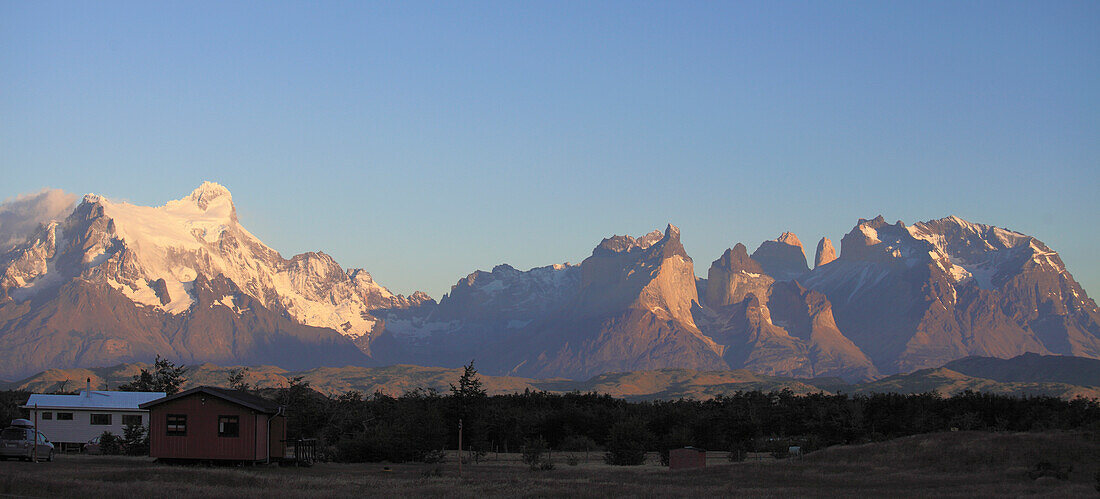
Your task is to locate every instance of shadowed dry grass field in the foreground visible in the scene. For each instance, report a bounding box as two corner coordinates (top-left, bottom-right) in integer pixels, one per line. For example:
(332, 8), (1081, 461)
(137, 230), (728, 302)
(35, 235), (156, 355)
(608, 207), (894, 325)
(0, 432), (1100, 498)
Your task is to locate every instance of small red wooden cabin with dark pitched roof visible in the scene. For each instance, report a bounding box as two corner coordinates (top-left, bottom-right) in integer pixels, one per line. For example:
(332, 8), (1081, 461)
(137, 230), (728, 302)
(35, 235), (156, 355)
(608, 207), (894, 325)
(140, 386), (286, 462)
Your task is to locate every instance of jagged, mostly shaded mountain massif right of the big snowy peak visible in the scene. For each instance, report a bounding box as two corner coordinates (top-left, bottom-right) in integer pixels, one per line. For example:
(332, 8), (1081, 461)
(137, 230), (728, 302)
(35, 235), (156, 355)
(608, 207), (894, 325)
(371, 217), (1100, 380)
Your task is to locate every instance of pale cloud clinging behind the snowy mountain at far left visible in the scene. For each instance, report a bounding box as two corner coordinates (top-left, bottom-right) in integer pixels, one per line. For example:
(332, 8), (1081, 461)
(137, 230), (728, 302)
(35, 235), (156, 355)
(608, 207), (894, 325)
(0, 189), (77, 252)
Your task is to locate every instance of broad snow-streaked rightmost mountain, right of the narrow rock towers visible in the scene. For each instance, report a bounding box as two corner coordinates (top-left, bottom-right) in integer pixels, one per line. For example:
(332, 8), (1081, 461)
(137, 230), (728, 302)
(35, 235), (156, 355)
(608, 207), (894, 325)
(800, 217), (1100, 373)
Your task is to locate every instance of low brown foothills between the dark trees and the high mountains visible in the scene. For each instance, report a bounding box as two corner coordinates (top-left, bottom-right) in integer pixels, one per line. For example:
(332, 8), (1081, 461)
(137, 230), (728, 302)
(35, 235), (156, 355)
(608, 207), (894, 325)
(8, 354), (1100, 400)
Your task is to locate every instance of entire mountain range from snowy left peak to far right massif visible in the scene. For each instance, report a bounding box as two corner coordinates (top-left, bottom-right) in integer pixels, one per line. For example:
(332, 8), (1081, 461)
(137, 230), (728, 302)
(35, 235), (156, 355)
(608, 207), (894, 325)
(0, 182), (1100, 381)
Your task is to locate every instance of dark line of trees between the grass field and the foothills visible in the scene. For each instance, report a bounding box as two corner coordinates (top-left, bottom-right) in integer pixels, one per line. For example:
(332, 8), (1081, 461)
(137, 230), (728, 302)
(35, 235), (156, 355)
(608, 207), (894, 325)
(0, 358), (1100, 467)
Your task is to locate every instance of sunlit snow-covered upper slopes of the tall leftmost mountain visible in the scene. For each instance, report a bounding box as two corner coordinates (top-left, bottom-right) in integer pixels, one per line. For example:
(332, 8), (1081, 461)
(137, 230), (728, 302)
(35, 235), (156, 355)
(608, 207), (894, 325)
(0, 181), (424, 337)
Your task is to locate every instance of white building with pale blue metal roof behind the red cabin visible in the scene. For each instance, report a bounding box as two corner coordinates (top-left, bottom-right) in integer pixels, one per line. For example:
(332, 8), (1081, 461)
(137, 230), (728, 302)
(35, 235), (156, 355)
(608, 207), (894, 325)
(22, 390), (164, 448)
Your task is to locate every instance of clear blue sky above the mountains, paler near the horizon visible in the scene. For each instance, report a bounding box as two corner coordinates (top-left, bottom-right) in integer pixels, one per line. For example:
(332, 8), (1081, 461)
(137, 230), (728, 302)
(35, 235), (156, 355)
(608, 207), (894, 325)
(0, 0), (1100, 298)
